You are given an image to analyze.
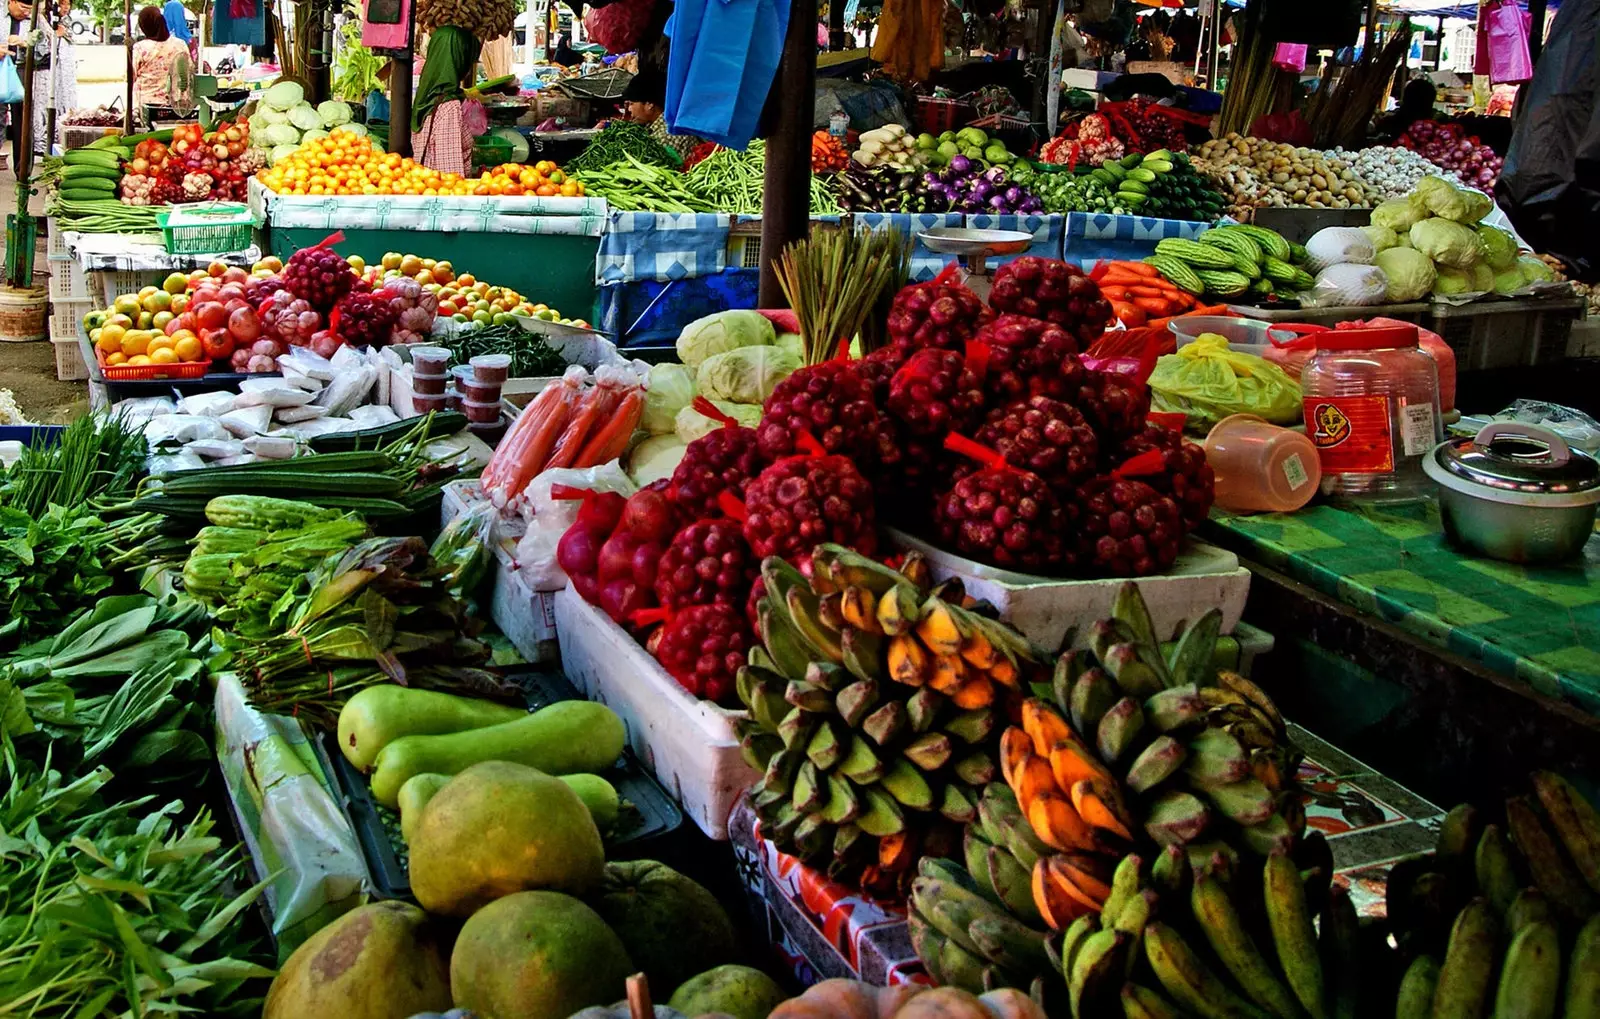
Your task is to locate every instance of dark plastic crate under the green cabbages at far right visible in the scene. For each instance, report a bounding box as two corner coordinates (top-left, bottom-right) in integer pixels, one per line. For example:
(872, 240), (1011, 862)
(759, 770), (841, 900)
(1434, 298), (1584, 371)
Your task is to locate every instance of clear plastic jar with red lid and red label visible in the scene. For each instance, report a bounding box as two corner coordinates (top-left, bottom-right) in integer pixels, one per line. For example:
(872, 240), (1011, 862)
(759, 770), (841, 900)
(1296, 325), (1443, 502)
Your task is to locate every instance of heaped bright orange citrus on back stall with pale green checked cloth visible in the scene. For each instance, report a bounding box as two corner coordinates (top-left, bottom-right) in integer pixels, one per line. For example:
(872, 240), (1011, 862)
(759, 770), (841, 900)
(256, 128), (477, 195)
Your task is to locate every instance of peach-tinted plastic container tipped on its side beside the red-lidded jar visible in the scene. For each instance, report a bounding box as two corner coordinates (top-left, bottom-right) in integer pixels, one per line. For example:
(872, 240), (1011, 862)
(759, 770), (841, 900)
(1205, 414), (1322, 513)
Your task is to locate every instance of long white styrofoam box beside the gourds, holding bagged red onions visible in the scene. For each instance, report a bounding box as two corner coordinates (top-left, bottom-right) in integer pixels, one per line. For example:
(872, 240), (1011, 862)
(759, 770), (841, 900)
(555, 587), (760, 840)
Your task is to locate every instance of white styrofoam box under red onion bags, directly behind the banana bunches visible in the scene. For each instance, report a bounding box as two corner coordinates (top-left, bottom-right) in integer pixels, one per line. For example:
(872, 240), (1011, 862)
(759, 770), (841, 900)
(890, 529), (1250, 651)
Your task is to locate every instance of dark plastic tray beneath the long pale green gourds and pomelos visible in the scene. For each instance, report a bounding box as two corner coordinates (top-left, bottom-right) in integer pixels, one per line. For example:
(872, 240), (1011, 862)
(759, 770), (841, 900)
(314, 672), (683, 899)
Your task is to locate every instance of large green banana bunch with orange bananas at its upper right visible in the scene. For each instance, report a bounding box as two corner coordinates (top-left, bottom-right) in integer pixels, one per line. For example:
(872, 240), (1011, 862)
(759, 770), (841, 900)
(738, 545), (1042, 894)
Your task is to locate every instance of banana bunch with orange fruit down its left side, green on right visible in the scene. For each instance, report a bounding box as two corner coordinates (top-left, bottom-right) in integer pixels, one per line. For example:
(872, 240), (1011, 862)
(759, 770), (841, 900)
(1000, 584), (1306, 929)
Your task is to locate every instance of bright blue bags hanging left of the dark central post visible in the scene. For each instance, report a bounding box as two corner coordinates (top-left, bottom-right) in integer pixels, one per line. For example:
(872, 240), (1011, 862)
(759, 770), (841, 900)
(664, 0), (789, 149)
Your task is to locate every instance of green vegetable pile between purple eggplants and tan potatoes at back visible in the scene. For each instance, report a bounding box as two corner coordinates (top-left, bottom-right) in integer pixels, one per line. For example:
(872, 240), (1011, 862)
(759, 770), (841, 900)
(1013, 149), (1226, 221)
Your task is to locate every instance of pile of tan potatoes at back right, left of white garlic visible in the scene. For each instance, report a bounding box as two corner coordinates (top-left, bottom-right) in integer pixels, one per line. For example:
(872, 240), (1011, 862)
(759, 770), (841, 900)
(1195, 133), (1373, 219)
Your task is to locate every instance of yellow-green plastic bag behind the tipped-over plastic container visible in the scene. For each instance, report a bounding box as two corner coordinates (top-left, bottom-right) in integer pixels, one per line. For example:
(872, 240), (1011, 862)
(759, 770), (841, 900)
(1150, 333), (1302, 429)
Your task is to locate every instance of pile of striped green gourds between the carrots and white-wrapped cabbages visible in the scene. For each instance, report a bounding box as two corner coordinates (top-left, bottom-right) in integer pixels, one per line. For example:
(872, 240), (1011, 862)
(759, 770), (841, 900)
(1144, 226), (1318, 304)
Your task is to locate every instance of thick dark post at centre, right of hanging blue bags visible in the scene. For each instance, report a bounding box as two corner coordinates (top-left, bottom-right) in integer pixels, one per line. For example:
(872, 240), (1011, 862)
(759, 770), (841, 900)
(758, 0), (816, 307)
